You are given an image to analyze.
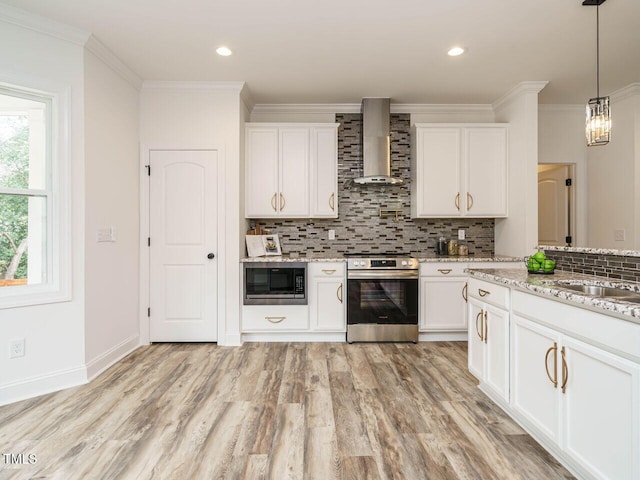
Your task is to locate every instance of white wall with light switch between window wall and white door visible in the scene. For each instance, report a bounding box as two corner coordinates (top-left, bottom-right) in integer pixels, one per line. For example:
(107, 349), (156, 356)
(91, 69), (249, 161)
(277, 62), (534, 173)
(84, 38), (140, 378)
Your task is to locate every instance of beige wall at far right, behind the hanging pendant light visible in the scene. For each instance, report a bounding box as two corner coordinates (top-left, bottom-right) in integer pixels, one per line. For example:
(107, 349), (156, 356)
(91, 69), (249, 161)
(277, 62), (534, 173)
(587, 84), (640, 250)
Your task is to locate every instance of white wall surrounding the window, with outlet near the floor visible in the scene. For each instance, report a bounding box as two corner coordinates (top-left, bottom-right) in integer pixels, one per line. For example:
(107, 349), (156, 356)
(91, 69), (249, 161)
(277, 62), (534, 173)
(0, 12), (87, 404)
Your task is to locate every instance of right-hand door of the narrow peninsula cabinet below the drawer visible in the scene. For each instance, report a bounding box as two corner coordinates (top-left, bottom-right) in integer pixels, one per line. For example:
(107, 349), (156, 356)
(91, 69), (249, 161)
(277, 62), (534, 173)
(484, 305), (509, 402)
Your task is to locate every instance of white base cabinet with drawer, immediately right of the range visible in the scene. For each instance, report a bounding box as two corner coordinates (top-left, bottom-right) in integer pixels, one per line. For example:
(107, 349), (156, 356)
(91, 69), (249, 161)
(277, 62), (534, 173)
(418, 262), (468, 332)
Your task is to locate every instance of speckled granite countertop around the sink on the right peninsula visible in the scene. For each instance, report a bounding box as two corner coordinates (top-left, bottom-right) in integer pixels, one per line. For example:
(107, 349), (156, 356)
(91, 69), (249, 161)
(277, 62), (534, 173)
(467, 268), (640, 324)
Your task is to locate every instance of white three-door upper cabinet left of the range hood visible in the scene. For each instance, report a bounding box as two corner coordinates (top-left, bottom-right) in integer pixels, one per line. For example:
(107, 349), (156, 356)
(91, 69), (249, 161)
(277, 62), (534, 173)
(245, 123), (338, 218)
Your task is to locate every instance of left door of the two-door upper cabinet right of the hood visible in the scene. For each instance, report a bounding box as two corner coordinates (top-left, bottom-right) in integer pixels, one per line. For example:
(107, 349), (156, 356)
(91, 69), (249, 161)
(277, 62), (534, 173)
(411, 128), (462, 217)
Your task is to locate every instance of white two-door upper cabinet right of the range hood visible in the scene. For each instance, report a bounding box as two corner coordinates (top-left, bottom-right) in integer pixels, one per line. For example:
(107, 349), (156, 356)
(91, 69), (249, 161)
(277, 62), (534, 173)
(411, 124), (508, 218)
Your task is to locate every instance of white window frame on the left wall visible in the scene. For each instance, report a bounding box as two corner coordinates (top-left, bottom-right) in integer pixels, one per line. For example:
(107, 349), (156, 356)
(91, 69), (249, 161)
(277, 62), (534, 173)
(0, 81), (71, 309)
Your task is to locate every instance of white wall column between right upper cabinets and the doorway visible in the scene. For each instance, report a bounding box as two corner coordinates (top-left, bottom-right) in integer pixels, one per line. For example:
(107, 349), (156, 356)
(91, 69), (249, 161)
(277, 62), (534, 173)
(494, 82), (547, 257)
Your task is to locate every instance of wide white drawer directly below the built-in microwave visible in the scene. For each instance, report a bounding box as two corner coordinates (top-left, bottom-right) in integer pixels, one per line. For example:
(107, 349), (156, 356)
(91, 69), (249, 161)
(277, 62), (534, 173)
(242, 305), (309, 332)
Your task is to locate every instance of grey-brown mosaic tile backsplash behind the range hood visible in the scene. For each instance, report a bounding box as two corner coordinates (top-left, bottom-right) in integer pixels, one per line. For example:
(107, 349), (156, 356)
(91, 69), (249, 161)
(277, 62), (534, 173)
(255, 114), (494, 256)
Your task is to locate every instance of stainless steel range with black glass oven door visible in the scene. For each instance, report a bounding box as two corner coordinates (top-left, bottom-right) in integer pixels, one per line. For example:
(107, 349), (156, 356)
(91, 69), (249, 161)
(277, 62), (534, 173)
(346, 253), (418, 343)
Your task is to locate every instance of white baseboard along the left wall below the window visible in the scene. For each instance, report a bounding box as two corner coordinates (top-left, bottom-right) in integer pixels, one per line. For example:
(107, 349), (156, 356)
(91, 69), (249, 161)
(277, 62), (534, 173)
(0, 365), (88, 405)
